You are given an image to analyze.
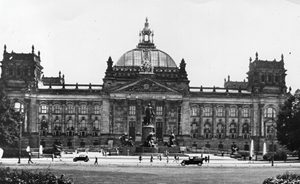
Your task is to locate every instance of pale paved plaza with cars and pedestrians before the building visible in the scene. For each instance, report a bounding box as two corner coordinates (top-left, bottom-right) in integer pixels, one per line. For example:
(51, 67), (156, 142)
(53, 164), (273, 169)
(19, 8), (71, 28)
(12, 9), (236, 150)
(0, 152), (300, 168)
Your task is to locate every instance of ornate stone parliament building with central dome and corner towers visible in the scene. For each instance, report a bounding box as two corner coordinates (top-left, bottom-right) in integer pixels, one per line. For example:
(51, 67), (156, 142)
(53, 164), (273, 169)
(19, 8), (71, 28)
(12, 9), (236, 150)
(1, 19), (287, 154)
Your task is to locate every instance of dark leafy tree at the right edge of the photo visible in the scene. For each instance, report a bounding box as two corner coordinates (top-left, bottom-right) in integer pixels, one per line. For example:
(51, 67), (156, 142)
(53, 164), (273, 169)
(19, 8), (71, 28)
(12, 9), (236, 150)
(277, 90), (300, 159)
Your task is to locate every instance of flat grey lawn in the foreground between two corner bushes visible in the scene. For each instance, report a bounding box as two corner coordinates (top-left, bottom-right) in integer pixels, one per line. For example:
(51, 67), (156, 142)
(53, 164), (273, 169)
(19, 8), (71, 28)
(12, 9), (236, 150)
(1, 164), (300, 184)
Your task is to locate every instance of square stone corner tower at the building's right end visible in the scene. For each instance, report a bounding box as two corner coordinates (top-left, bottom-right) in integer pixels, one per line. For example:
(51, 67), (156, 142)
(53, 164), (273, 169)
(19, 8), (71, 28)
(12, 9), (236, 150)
(247, 53), (286, 94)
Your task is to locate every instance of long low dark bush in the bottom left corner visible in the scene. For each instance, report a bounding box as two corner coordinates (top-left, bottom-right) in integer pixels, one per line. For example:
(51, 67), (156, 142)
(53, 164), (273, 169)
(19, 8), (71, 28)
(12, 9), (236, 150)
(0, 167), (73, 184)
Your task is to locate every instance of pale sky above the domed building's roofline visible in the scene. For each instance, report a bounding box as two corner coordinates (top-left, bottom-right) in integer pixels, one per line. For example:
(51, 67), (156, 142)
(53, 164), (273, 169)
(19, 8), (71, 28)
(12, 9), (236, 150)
(0, 0), (300, 91)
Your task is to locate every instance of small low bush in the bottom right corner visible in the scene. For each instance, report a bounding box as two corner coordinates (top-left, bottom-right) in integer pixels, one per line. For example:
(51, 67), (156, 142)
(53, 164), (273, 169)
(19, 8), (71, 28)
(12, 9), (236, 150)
(263, 172), (300, 184)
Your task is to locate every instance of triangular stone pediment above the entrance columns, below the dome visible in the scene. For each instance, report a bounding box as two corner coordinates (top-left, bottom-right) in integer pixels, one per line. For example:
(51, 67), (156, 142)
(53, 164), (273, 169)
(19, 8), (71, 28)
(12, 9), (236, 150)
(111, 79), (178, 93)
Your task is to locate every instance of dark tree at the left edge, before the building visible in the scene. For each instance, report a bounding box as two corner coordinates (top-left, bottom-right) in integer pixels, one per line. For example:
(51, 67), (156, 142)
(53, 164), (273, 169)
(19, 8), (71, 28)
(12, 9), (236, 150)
(0, 88), (22, 147)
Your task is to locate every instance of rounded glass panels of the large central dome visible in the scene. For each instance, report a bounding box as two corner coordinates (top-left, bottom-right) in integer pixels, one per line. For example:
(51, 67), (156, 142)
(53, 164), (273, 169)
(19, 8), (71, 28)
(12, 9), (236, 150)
(115, 48), (177, 68)
